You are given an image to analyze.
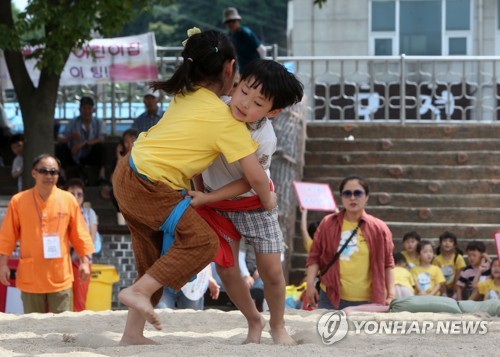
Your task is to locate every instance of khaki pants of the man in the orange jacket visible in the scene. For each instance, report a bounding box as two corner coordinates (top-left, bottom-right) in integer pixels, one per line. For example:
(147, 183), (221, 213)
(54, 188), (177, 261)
(21, 289), (73, 314)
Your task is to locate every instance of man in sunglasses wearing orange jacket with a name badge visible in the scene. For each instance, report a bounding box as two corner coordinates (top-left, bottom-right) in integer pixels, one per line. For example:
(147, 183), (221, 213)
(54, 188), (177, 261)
(0, 154), (94, 313)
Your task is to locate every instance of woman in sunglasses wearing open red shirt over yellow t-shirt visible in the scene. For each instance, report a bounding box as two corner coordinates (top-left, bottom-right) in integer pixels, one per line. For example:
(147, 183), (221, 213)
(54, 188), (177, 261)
(306, 175), (395, 310)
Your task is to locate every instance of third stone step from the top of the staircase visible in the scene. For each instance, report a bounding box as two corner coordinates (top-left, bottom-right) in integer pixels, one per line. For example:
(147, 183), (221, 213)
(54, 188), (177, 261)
(305, 151), (500, 169)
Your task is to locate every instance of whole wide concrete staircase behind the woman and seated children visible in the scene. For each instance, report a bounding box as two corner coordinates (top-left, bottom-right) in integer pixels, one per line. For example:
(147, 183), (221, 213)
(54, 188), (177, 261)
(290, 123), (500, 283)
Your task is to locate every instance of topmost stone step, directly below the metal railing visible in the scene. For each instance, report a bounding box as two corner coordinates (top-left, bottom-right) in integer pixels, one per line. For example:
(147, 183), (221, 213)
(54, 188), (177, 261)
(307, 123), (500, 140)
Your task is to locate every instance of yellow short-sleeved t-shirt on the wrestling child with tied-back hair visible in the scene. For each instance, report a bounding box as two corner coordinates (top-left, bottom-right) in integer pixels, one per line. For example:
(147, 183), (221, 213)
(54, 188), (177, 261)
(132, 88), (257, 190)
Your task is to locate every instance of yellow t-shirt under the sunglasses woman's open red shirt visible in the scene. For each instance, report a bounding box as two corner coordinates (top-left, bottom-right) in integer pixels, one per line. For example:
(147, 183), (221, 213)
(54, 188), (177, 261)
(339, 220), (372, 301)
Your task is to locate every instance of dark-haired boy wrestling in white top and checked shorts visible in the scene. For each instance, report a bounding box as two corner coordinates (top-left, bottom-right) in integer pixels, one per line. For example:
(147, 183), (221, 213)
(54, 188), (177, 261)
(189, 59), (303, 345)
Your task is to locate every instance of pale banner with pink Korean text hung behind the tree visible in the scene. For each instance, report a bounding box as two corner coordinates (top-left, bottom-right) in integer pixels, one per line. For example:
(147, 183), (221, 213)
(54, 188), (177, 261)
(0, 32), (158, 89)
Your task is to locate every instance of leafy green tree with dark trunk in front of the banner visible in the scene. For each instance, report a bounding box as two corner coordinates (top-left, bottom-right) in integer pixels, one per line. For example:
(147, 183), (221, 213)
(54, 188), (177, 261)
(0, 0), (169, 186)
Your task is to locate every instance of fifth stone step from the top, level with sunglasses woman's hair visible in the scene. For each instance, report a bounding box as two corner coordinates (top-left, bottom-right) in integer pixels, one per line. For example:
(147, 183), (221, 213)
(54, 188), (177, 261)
(304, 177), (500, 196)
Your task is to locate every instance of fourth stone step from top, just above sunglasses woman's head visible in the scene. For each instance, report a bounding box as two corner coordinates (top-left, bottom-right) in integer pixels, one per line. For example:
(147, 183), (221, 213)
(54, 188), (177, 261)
(304, 164), (500, 182)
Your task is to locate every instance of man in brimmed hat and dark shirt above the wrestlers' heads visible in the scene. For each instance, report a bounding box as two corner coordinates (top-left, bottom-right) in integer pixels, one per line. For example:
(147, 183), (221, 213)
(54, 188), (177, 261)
(223, 7), (266, 72)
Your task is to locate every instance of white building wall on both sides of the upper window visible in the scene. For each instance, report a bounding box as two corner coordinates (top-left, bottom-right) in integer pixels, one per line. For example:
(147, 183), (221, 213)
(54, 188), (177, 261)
(289, 0), (500, 56)
